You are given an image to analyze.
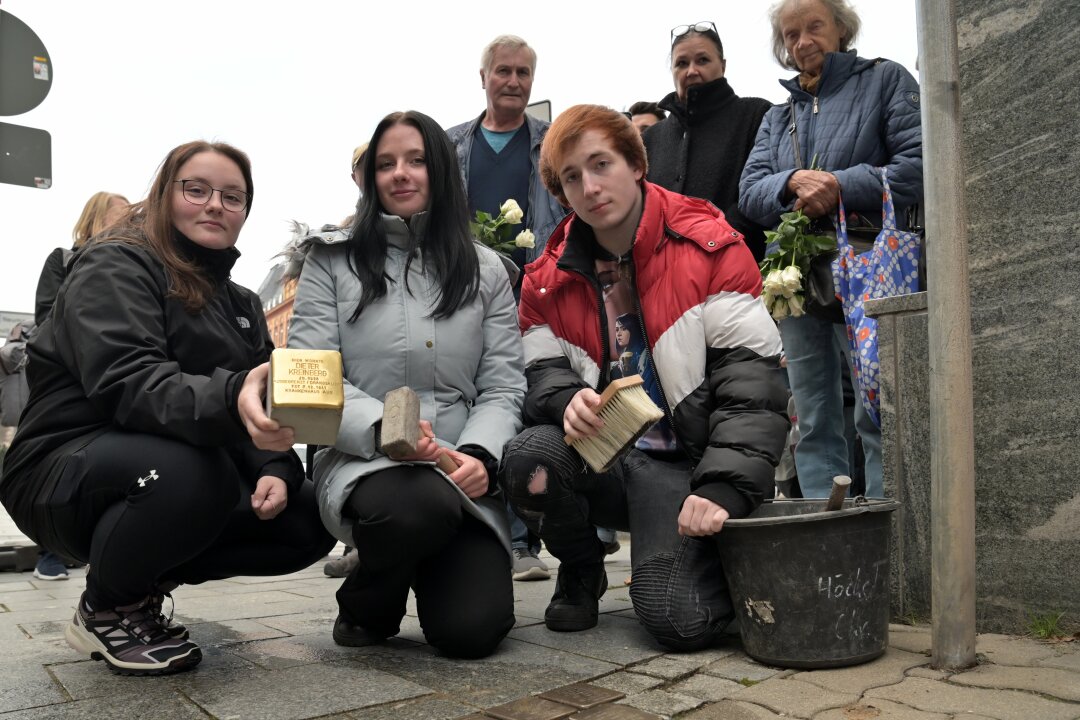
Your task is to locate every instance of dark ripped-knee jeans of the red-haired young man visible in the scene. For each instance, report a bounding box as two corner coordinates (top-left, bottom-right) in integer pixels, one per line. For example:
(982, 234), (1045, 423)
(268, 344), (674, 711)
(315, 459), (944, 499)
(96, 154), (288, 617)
(499, 425), (734, 651)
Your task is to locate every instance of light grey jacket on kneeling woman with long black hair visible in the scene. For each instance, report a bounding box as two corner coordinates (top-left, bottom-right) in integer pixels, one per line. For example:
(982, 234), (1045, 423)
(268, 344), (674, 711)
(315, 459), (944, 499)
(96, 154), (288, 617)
(288, 214), (525, 553)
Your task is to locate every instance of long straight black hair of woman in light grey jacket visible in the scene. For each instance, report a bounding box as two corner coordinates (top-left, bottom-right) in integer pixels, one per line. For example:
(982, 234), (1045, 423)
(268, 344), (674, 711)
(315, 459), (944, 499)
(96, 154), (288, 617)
(347, 110), (480, 323)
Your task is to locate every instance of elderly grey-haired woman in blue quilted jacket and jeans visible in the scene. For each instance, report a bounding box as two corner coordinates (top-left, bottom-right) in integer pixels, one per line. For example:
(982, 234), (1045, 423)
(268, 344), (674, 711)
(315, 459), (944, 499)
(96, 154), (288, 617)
(739, 0), (922, 497)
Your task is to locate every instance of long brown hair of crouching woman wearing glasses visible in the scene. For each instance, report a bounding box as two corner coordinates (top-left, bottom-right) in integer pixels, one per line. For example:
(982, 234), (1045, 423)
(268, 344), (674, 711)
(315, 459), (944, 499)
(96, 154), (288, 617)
(95, 140), (255, 313)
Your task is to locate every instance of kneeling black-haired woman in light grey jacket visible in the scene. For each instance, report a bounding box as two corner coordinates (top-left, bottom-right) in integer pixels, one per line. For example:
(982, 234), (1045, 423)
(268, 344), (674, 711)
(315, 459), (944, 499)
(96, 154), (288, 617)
(288, 111), (525, 657)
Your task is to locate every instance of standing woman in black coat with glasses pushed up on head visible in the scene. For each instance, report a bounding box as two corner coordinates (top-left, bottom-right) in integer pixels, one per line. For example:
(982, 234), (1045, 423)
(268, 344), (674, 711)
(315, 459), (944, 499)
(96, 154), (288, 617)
(642, 22), (772, 260)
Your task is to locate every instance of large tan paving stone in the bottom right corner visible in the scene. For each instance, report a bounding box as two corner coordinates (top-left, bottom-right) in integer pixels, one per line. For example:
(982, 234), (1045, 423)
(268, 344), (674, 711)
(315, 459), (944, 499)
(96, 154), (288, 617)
(864, 678), (1080, 720)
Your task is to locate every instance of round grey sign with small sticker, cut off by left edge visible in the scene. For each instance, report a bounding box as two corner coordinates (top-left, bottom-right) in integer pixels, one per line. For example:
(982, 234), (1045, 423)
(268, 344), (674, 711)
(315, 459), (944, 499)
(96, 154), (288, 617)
(0, 10), (53, 116)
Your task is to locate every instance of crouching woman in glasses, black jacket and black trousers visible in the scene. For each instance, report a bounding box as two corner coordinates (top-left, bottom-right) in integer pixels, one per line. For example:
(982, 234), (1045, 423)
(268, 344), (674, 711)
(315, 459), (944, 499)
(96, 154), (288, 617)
(0, 141), (334, 675)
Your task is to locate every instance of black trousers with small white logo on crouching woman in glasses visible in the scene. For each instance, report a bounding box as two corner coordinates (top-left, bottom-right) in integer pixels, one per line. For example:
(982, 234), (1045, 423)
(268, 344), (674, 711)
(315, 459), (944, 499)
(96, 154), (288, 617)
(50, 432), (335, 608)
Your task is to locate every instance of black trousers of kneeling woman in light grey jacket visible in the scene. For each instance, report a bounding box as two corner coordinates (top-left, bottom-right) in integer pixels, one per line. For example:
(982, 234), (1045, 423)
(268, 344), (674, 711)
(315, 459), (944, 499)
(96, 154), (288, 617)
(337, 465), (514, 657)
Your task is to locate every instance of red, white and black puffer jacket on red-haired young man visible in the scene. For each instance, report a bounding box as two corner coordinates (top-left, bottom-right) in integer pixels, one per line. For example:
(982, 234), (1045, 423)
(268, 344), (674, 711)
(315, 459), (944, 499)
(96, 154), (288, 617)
(518, 182), (788, 517)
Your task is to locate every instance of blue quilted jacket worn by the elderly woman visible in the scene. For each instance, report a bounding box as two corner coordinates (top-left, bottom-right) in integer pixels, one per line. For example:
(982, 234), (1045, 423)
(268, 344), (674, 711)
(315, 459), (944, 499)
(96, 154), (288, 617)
(739, 53), (922, 228)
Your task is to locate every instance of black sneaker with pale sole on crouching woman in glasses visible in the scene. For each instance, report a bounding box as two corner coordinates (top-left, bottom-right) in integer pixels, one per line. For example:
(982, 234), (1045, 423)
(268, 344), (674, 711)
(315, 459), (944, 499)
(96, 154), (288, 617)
(64, 597), (202, 675)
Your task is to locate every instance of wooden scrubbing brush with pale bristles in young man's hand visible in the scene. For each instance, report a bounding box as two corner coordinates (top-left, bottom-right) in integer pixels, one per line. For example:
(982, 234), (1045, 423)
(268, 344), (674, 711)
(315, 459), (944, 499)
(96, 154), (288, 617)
(563, 375), (664, 473)
